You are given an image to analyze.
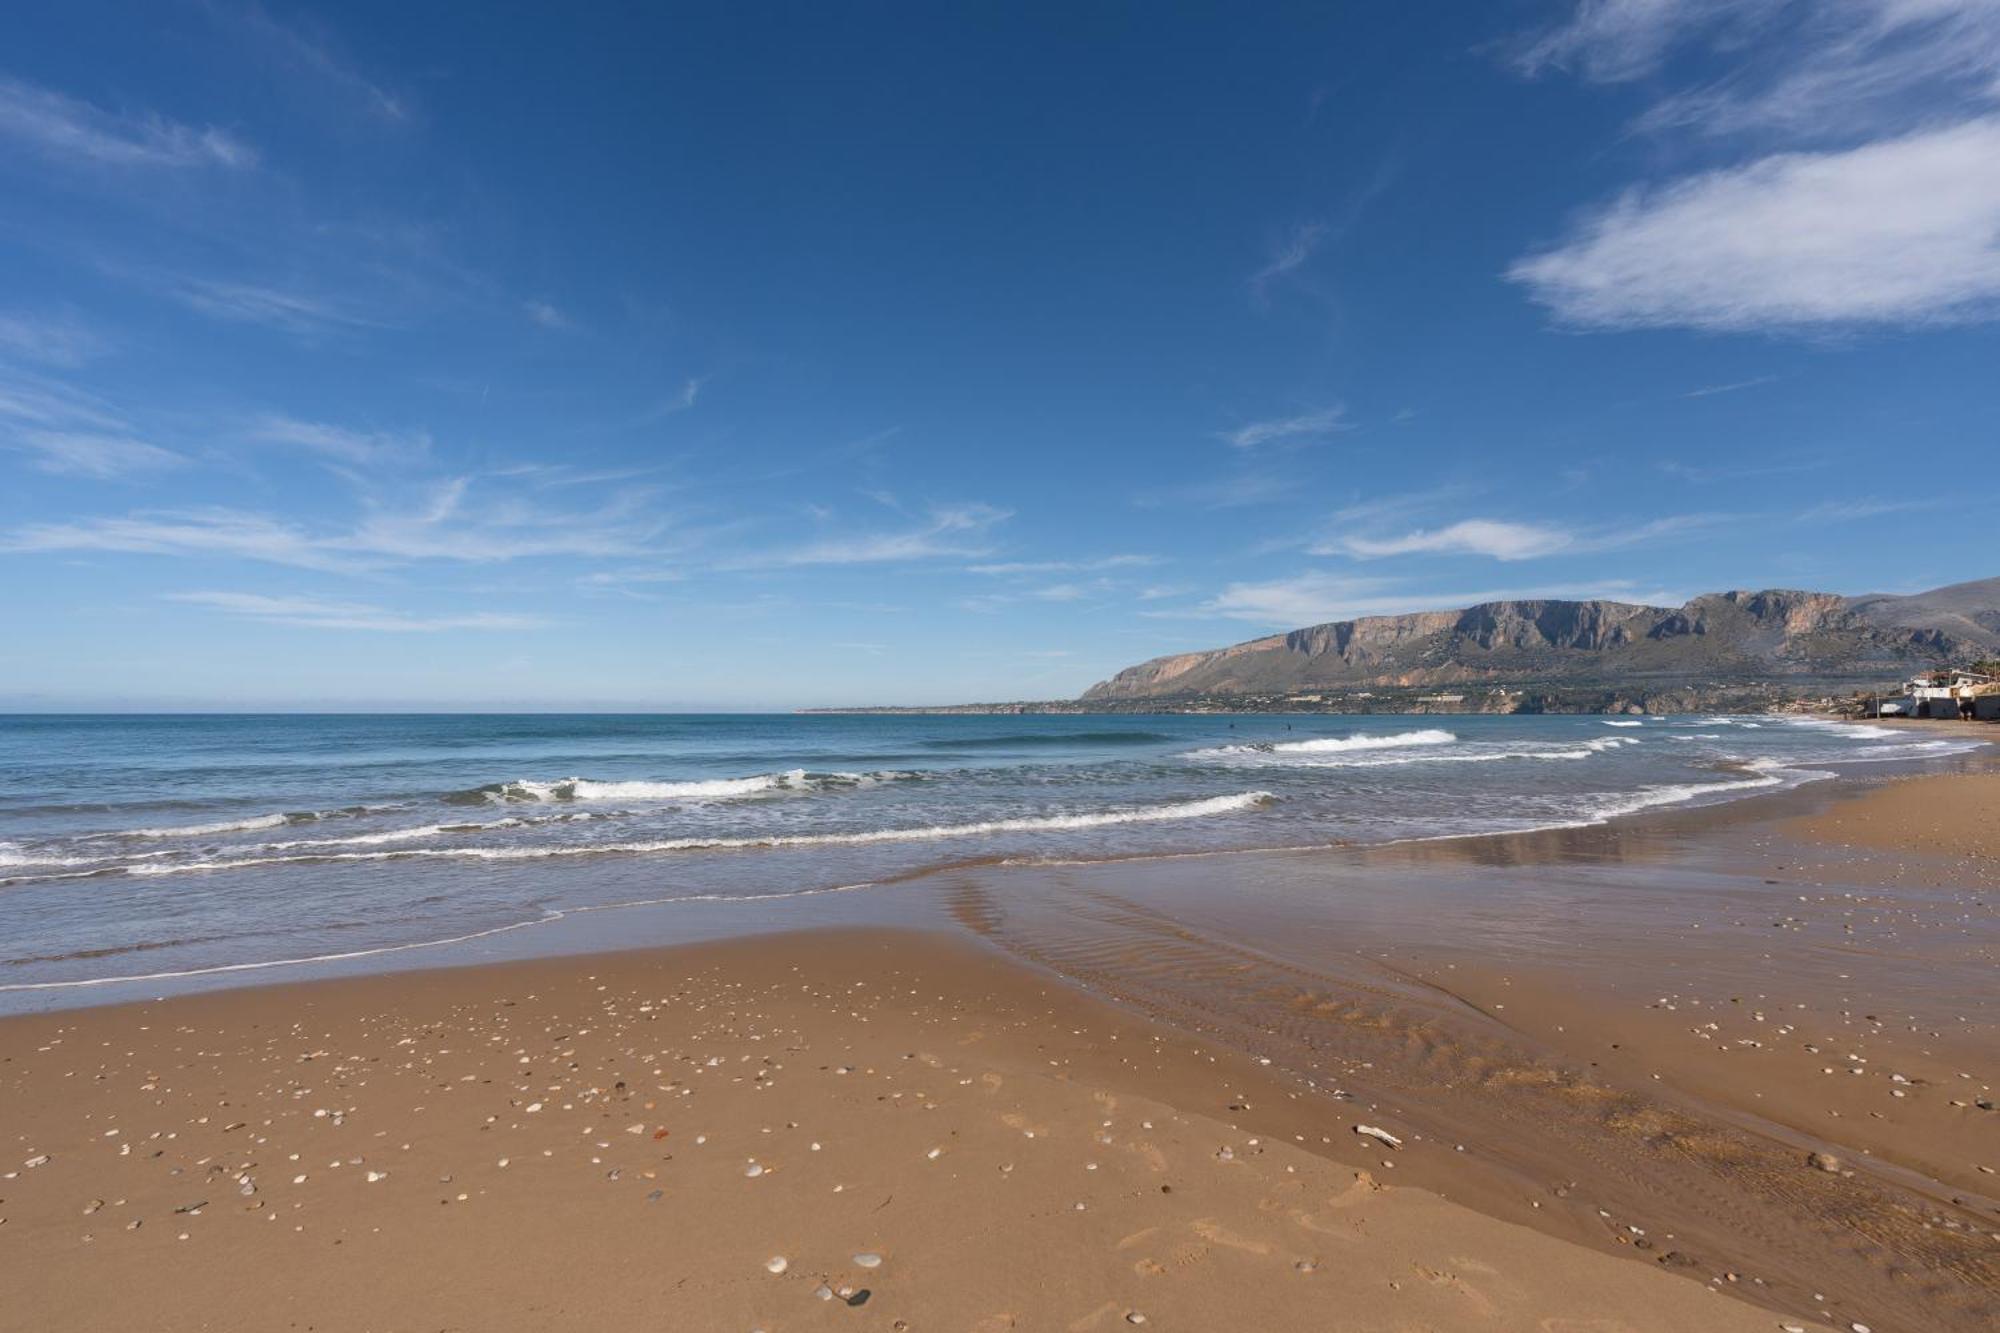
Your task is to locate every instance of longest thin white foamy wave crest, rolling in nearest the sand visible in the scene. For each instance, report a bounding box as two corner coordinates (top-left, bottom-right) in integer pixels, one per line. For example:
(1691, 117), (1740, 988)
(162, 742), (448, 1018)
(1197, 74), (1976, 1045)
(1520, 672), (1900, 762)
(118, 791), (1278, 875)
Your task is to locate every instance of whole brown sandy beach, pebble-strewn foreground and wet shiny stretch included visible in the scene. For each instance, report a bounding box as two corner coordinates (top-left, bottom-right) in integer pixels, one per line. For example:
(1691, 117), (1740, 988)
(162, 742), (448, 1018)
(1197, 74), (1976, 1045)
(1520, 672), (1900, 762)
(0, 761), (2000, 1333)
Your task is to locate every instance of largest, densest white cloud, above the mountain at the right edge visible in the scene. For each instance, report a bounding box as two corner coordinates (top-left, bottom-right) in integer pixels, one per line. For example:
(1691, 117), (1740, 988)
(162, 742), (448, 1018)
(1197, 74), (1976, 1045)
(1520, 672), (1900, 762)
(1508, 118), (2000, 330)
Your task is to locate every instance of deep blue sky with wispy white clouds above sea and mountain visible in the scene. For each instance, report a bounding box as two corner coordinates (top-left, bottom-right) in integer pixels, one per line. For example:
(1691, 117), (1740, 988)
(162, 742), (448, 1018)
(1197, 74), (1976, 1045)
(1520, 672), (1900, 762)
(0, 0), (2000, 711)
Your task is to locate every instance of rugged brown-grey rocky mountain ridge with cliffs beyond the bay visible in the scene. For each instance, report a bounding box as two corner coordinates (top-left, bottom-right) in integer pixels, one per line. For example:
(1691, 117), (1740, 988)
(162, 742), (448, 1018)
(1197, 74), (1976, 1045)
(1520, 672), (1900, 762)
(1084, 578), (2000, 701)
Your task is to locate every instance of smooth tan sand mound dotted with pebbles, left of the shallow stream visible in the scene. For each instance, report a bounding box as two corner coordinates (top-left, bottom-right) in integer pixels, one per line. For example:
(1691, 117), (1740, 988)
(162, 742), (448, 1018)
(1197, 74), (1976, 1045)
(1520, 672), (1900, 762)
(0, 931), (1824, 1333)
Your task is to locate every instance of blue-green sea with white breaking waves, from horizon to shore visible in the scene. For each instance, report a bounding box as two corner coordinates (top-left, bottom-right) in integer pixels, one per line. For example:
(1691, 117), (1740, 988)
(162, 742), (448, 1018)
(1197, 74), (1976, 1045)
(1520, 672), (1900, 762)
(0, 715), (1980, 999)
